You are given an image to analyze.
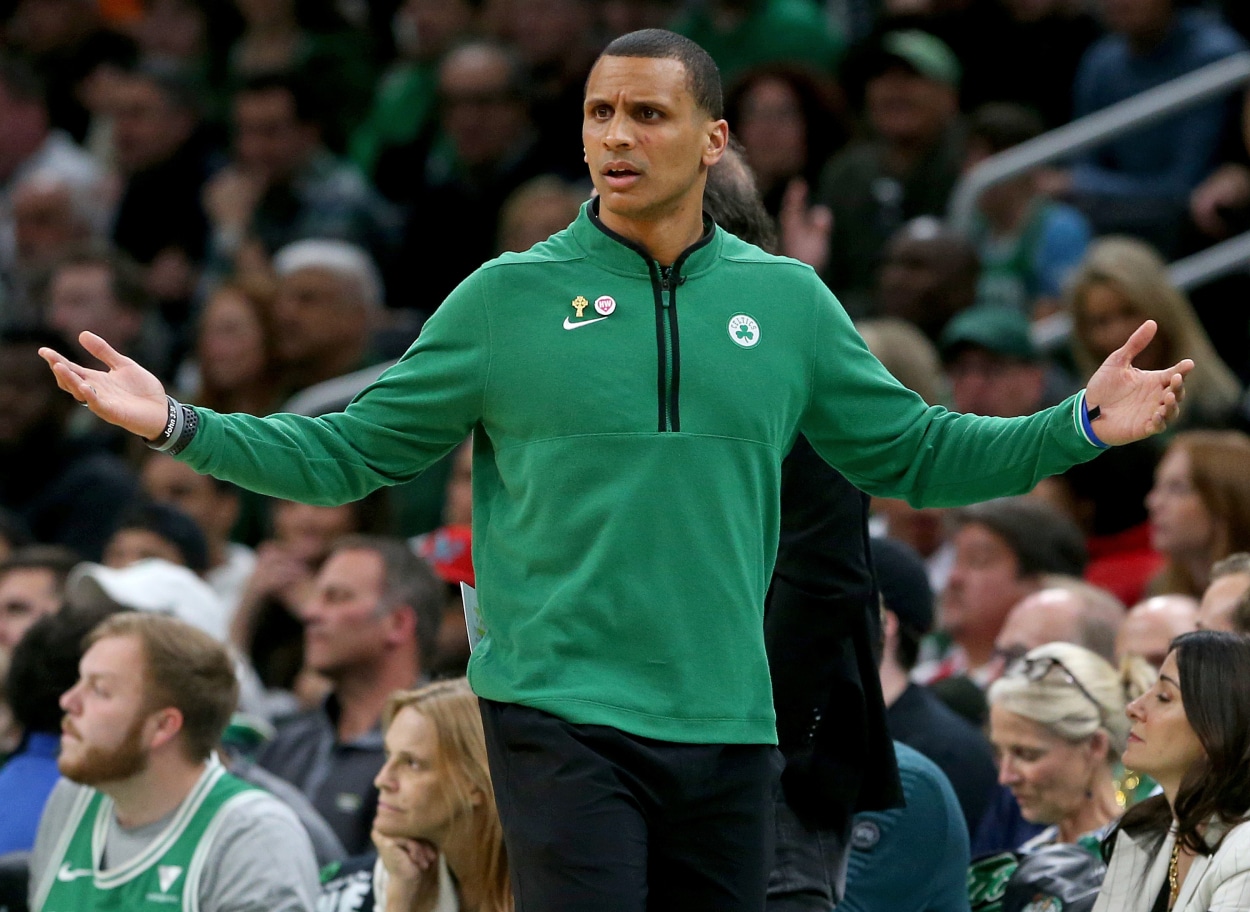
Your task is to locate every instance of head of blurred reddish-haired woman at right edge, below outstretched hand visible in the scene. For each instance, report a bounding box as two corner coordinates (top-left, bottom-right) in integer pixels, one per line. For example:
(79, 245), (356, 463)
(1146, 431), (1250, 598)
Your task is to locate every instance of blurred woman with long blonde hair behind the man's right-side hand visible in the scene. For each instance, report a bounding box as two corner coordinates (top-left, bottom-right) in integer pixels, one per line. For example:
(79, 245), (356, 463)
(1068, 236), (1241, 427)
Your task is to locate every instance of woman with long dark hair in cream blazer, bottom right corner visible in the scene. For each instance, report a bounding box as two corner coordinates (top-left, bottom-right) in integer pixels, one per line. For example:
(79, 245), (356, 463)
(1094, 631), (1250, 912)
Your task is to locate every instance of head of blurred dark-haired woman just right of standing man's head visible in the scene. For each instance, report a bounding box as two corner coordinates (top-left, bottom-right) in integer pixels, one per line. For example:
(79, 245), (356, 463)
(725, 64), (850, 217)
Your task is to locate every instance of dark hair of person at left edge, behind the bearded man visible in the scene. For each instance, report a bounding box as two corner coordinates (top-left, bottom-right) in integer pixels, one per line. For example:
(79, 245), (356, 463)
(6, 606), (118, 733)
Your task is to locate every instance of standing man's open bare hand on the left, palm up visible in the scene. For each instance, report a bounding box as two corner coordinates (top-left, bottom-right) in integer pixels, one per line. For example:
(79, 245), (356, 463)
(39, 332), (169, 440)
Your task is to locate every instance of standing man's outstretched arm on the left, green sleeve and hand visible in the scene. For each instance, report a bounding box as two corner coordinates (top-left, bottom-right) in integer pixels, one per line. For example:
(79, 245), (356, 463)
(41, 282), (490, 503)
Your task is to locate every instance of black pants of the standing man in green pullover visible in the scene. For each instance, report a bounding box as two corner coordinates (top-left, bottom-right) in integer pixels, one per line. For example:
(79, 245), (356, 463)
(480, 700), (781, 912)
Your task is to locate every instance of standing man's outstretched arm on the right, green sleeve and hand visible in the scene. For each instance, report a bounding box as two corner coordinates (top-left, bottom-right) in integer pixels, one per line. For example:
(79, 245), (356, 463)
(800, 289), (1193, 506)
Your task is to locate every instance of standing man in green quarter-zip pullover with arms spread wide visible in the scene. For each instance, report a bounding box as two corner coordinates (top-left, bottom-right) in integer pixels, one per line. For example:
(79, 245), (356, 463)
(43, 30), (1193, 912)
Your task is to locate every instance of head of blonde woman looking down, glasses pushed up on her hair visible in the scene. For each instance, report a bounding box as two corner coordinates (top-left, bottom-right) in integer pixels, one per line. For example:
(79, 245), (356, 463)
(989, 642), (1154, 852)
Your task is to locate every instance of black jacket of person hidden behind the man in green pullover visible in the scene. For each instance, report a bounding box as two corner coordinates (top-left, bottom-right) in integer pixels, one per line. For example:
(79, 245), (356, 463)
(764, 436), (903, 830)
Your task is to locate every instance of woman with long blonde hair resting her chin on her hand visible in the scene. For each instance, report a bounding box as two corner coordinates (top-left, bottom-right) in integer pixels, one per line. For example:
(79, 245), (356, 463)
(373, 678), (513, 912)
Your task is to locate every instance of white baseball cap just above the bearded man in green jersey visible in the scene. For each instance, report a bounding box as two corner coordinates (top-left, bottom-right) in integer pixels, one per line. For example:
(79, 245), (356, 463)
(65, 557), (230, 642)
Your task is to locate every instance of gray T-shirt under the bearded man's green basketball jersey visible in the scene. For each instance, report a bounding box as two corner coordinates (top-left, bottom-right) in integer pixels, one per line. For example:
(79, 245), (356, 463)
(30, 778), (319, 912)
